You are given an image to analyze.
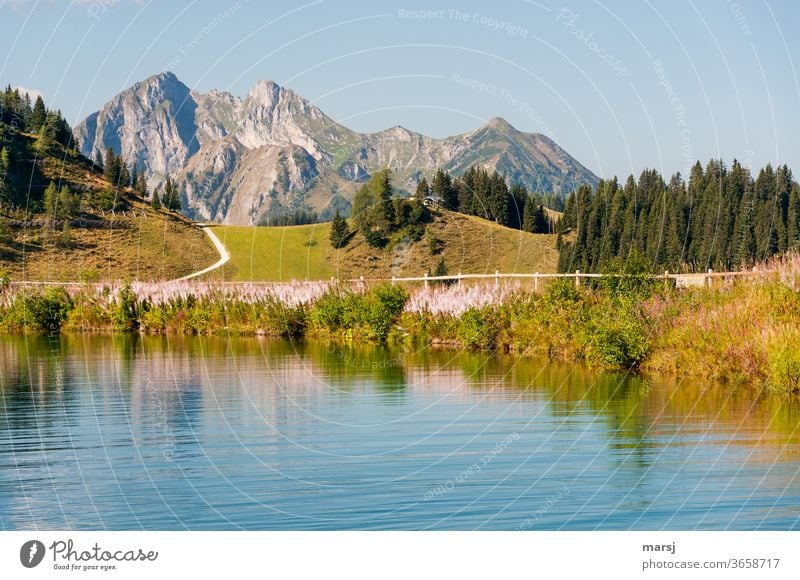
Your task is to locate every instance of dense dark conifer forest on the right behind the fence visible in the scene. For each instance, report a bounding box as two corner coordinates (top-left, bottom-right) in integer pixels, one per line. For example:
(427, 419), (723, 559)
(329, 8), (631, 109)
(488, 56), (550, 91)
(558, 159), (800, 272)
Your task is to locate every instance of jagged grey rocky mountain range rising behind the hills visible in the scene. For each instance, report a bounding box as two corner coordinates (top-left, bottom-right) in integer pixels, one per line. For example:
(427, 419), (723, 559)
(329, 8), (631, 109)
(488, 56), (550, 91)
(75, 73), (597, 224)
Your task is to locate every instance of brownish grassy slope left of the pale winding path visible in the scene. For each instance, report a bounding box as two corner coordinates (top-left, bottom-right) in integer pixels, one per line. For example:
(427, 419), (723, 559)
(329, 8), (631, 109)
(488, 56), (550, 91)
(0, 133), (219, 281)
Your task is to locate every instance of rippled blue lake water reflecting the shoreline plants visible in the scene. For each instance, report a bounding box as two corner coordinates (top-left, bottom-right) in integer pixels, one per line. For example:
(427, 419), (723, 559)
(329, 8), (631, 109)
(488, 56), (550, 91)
(0, 335), (800, 530)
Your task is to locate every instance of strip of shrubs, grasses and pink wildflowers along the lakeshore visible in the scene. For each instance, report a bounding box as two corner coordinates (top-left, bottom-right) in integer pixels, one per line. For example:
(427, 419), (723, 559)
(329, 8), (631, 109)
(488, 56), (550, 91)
(0, 255), (800, 392)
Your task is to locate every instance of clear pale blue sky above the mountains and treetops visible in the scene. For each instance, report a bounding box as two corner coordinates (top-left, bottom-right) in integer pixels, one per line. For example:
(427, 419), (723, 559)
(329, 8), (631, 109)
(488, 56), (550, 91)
(0, 0), (800, 176)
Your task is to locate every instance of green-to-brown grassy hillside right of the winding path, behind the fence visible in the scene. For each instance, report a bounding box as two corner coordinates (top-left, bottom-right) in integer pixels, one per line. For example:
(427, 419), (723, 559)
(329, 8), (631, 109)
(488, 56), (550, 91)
(209, 212), (558, 281)
